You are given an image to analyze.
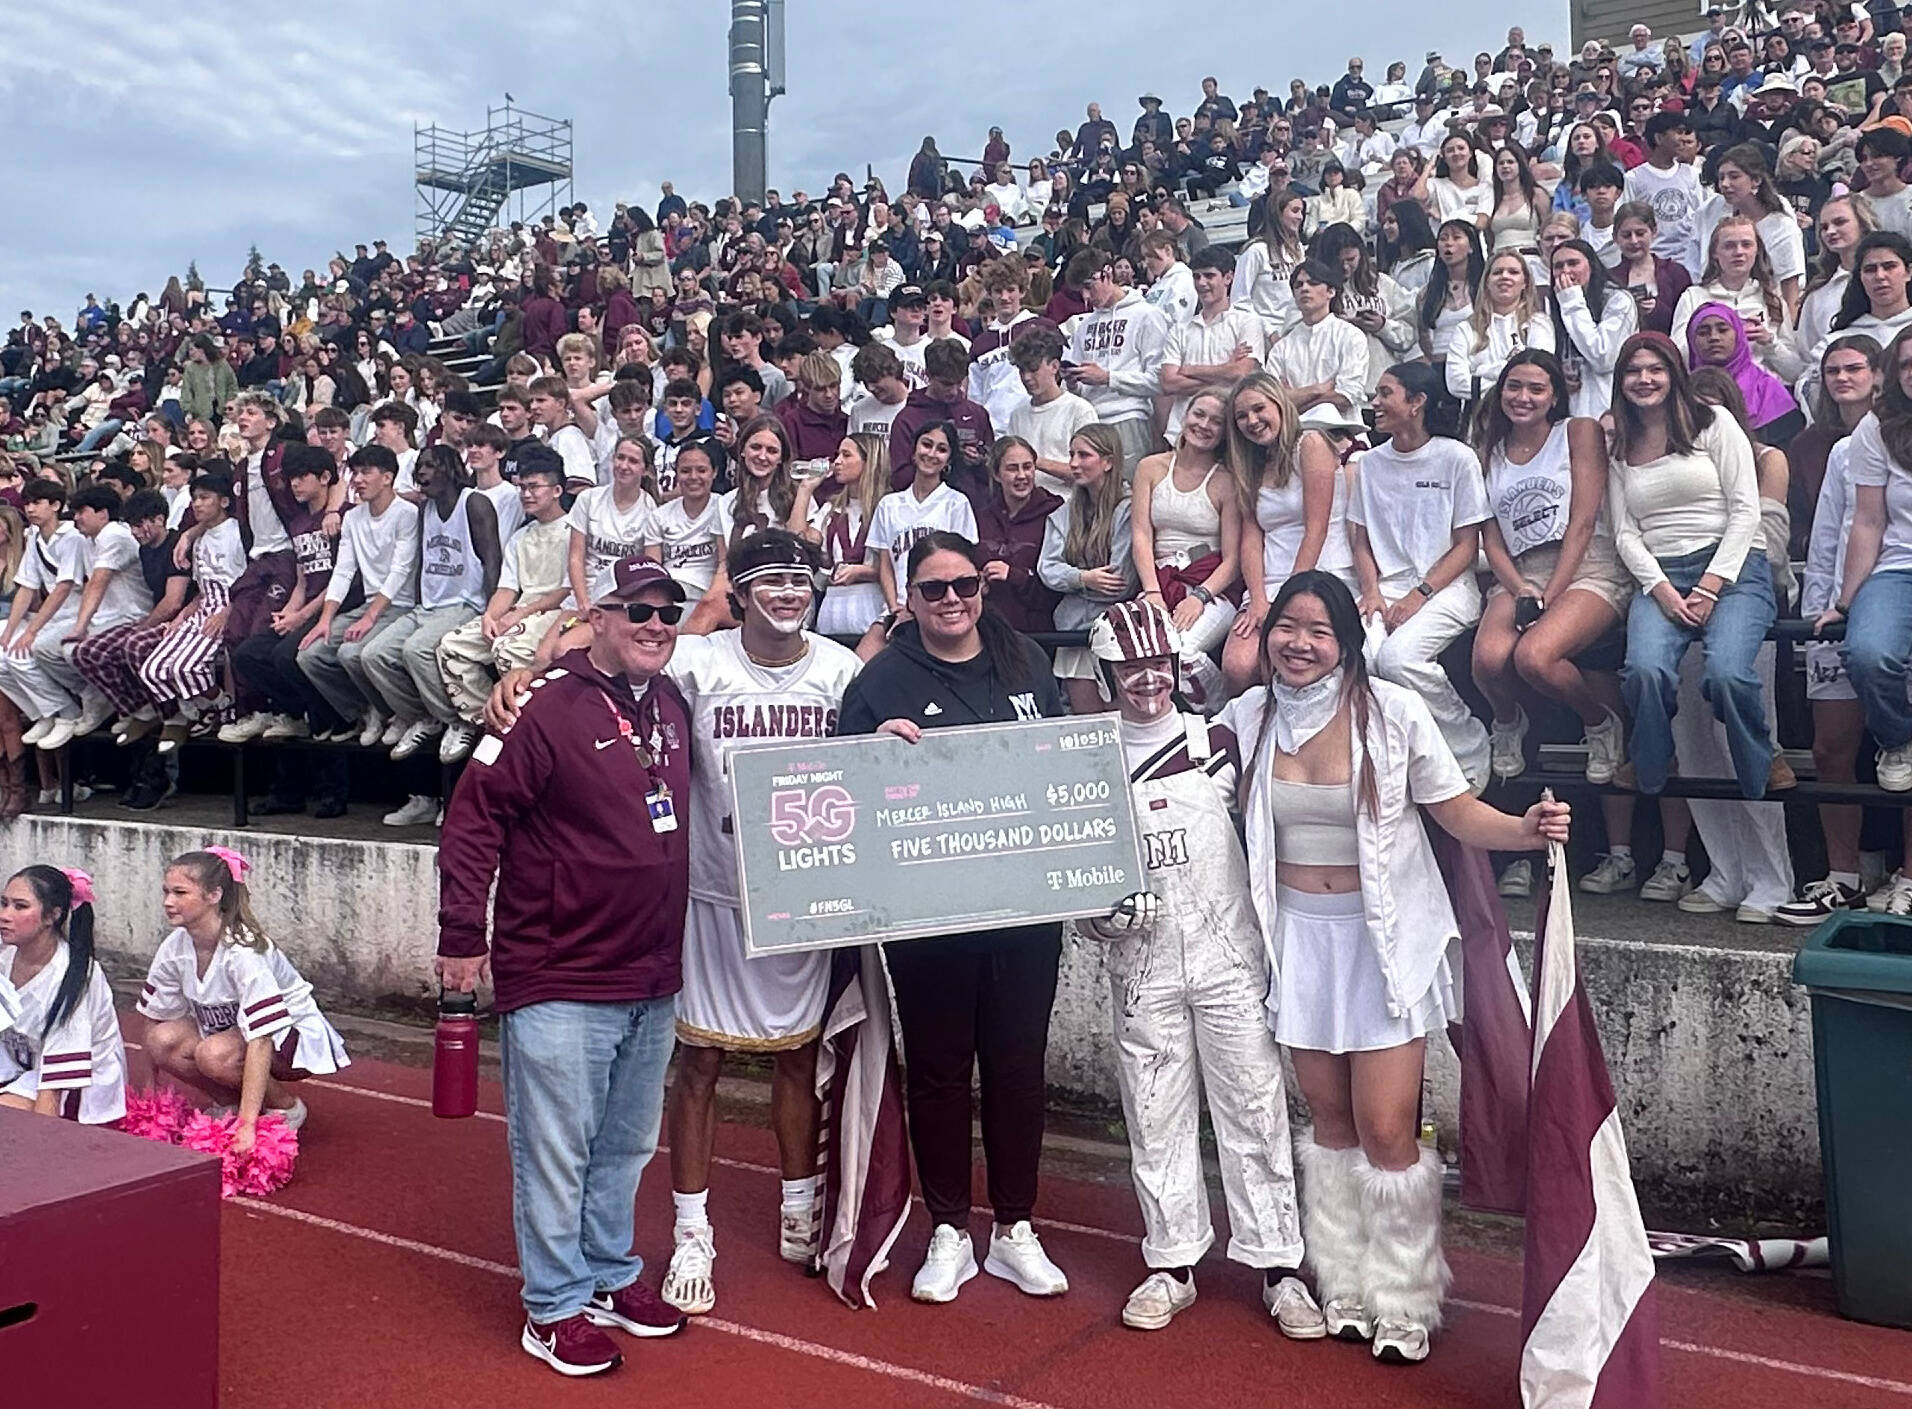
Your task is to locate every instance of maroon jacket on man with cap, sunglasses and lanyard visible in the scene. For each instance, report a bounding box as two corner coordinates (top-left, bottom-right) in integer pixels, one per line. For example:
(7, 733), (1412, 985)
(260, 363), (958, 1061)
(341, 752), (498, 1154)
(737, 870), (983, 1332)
(438, 650), (690, 1013)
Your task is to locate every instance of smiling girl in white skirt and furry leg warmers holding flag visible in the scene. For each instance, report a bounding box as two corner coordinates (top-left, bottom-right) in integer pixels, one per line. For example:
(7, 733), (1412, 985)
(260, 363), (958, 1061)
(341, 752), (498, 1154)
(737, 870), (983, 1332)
(1222, 572), (1568, 1361)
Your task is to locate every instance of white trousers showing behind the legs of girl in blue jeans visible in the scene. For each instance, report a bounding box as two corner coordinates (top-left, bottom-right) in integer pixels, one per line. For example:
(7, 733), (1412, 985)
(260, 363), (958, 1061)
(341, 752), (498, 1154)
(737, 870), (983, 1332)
(1673, 640), (1793, 910)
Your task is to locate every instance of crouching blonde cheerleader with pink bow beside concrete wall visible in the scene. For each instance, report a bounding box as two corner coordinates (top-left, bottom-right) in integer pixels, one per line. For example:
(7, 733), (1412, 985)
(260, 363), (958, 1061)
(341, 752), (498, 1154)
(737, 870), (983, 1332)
(140, 847), (352, 1153)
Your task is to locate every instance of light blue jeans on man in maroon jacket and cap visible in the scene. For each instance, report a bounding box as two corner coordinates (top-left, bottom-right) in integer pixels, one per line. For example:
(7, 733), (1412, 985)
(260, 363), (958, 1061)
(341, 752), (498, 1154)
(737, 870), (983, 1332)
(499, 996), (677, 1325)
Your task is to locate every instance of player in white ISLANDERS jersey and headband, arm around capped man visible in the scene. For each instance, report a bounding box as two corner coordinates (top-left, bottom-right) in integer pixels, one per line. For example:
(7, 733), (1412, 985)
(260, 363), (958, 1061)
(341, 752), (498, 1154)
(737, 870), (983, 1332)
(478, 528), (858, 1315)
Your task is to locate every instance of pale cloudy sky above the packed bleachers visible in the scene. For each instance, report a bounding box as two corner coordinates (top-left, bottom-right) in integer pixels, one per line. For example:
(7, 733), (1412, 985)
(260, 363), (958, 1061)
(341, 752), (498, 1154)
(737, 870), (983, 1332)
(0, 0), (1566, 325)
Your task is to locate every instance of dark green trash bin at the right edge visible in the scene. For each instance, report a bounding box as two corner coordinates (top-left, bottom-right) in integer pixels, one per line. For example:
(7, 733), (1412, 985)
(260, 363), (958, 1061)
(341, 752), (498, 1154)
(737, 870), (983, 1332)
(1793, 912), (1912, 1329)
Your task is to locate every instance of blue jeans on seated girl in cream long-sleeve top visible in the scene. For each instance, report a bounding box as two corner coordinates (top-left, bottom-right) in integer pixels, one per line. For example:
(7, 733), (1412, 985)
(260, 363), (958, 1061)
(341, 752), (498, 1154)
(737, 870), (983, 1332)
(1619, 549), (1778, 799)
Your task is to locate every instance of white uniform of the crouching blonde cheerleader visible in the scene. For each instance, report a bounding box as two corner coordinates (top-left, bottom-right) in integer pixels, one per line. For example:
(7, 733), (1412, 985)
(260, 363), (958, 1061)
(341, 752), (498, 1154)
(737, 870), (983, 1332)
(140, 929), (352, 1076)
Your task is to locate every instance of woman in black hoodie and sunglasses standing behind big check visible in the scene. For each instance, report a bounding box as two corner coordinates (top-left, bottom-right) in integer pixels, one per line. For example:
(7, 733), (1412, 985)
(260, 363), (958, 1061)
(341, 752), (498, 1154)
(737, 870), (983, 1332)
(837, 531), (1069, 1302)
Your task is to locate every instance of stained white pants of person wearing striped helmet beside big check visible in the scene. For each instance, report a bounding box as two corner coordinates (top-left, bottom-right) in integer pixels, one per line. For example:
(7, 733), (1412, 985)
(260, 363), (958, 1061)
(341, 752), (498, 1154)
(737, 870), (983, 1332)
(1107, 906), (1302, 1268)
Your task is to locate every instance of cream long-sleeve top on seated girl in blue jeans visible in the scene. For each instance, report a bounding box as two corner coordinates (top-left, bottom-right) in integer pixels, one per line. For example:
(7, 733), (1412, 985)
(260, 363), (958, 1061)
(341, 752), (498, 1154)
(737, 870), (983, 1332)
(1606, 411), (1759, 593)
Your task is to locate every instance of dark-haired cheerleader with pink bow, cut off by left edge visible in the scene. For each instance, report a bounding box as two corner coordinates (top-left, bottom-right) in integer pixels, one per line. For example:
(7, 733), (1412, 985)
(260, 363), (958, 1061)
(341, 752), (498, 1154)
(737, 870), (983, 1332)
(0, 866), (126, 1126)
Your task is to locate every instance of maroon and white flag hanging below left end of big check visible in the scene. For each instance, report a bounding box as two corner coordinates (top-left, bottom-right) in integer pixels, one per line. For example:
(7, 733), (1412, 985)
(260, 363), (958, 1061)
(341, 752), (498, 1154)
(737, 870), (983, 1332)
(816, 944), (910, 1308)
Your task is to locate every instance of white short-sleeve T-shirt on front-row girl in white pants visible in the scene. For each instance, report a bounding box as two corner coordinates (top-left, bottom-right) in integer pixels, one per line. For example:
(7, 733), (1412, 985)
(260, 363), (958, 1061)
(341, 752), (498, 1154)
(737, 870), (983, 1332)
(1348, 436), (1493, 583)
